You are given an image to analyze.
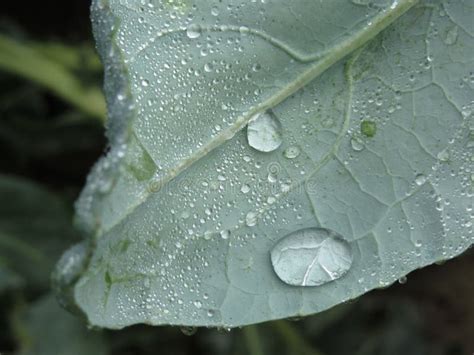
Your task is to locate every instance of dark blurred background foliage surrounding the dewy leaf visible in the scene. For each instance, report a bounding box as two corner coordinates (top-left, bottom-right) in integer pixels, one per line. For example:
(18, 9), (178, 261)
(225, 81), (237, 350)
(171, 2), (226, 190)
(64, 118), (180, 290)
(0, 0), (474, 355)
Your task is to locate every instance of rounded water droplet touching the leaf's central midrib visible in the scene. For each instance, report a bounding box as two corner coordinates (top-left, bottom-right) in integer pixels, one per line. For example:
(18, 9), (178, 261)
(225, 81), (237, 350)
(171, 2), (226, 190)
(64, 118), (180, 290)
(247, 111), (282, 152)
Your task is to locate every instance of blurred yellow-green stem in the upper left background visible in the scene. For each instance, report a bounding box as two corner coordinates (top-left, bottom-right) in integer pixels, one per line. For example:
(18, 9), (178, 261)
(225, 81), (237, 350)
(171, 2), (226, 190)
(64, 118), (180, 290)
(0, 35), (106, 121)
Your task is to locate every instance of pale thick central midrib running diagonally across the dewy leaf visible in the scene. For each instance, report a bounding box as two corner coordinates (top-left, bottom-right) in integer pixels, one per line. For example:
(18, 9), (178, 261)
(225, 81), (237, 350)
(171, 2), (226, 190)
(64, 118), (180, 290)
(98, 0), (419, 238)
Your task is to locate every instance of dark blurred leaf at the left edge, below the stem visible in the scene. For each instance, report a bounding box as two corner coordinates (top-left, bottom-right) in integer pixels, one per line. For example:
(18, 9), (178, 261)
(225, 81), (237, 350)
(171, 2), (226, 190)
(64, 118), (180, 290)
(0, 174), (78, 290)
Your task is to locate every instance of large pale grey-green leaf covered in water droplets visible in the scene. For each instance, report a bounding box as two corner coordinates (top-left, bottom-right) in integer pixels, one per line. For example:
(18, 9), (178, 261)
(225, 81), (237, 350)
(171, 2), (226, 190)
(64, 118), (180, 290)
(63, 0), (474, 328)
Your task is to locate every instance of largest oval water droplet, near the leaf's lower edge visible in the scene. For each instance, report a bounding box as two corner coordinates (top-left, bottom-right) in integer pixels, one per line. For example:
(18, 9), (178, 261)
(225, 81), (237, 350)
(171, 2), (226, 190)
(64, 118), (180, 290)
(271, 228), (352, 286)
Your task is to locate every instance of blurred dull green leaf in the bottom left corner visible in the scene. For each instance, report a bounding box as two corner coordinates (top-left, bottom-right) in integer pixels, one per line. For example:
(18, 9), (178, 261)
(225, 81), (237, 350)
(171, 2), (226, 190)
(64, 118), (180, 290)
(15, 295), (108, 355)
